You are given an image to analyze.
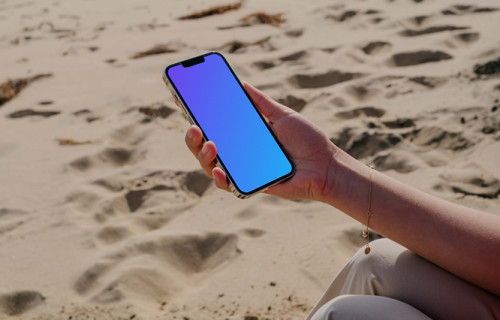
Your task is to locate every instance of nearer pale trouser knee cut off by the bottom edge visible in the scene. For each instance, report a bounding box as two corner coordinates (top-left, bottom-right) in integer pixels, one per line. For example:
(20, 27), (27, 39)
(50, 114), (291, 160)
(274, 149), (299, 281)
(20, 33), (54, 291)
(311, 295), (430, 320)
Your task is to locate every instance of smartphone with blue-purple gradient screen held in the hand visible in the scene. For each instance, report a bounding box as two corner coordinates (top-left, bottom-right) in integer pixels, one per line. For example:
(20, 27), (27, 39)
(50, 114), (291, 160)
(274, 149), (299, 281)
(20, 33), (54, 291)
(163, 52), (295, 198)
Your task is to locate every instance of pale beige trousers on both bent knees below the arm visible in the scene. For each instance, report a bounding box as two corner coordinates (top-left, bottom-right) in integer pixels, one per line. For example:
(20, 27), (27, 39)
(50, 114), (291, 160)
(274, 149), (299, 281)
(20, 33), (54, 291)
(306, 239), (500, 320)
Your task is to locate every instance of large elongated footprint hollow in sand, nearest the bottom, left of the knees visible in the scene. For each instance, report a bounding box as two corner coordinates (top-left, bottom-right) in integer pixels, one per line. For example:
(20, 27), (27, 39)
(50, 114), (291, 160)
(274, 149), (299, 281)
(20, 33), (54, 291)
(73, 233), (241, 303)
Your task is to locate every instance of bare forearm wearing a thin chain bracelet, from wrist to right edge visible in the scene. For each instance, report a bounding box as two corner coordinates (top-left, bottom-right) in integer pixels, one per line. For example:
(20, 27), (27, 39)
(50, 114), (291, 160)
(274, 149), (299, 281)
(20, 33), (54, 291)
(325, 146), (500, 295)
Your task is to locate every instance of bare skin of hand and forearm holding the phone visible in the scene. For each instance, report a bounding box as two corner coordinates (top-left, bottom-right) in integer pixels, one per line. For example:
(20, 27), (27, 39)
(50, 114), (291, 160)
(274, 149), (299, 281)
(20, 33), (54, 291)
(180, 83), (500, 296)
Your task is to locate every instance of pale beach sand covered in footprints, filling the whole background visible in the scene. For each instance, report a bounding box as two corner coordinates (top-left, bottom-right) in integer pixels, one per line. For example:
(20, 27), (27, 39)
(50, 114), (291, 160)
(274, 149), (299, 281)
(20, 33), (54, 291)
(0, 0), (500, 320)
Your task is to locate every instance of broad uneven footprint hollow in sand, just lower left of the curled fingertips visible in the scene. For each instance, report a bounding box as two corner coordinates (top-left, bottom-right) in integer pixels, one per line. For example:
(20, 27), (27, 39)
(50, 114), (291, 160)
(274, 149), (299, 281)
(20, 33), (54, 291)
(65, 170), (212, 235)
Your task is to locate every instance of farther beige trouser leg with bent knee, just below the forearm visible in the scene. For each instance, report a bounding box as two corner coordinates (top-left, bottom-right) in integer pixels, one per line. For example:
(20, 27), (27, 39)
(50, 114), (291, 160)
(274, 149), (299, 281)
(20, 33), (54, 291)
(306, 239), (500, 320)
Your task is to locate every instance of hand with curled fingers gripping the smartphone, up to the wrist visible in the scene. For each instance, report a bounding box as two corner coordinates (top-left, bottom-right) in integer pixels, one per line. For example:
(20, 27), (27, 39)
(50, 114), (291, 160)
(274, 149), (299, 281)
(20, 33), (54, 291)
(186, 82), (336, 201)
